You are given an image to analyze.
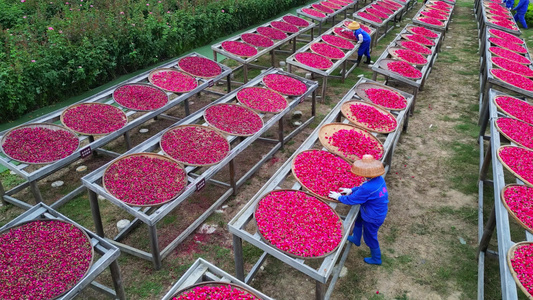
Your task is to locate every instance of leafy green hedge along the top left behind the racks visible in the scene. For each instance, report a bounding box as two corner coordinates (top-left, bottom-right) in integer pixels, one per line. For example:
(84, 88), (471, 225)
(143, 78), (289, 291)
(0, 0), (307, 123)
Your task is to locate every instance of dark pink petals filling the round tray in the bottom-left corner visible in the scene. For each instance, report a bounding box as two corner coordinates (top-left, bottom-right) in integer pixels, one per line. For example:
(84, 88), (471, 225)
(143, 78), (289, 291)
(0, 220), (93, 300)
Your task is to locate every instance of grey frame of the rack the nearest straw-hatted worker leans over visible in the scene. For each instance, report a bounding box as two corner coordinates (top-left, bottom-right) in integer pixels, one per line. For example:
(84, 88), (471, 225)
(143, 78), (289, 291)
(228, 78), (414, 300)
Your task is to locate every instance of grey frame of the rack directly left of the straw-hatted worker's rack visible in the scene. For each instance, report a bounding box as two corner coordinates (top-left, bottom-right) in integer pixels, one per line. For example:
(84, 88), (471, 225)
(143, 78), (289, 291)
(82, 68), (318, 270)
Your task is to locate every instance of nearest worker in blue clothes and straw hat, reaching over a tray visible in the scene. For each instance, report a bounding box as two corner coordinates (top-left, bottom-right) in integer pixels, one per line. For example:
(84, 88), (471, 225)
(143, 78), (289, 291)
(329, 154), (389, 265)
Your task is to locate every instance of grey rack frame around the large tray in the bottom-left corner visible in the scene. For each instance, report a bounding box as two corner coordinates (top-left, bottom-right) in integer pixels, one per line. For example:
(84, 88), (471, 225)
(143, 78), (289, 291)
(0, 203), (126, 300)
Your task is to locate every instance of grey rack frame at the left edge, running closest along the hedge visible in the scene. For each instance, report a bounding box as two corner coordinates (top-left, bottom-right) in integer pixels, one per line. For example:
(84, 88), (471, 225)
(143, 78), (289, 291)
(0, 52), (232, 209)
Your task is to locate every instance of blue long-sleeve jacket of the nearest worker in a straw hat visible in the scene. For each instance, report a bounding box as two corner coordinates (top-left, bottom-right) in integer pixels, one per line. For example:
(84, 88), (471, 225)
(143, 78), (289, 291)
(339, 176), (389, 223)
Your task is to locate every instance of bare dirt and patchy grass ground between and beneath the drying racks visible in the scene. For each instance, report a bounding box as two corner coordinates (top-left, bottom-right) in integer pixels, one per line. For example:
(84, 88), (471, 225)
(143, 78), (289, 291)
(0, 0), (520, 300)
